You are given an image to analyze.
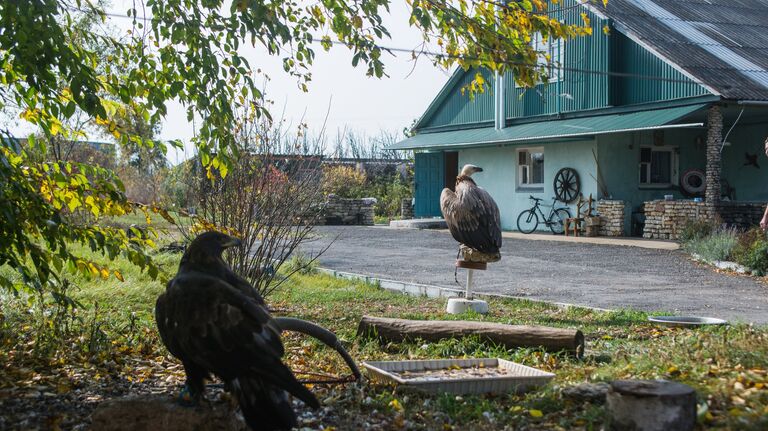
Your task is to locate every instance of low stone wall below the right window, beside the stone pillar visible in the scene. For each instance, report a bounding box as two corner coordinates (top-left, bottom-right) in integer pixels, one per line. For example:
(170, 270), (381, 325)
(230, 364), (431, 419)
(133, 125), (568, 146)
(643, 200), (765, 239)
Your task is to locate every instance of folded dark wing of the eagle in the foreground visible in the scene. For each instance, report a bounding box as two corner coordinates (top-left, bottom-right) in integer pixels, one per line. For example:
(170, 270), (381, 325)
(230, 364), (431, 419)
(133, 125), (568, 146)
(155, 272), (318, 406)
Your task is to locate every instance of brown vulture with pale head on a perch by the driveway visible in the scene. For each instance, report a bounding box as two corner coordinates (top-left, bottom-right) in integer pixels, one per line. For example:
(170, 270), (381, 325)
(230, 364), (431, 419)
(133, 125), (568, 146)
(440, 165), (501, 254)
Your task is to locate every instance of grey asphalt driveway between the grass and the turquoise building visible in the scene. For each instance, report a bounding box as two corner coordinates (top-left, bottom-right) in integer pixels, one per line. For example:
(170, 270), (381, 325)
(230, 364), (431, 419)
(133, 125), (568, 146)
(305, 226), (768, 324)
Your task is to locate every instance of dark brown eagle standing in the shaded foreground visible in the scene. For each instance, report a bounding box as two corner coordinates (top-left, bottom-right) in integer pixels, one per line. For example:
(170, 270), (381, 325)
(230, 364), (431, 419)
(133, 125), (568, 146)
(155, 232), (319, 430)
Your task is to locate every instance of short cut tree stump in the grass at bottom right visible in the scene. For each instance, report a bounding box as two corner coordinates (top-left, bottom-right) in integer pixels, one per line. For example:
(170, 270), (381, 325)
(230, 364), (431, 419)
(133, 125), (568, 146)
(606, 380), (696, 431)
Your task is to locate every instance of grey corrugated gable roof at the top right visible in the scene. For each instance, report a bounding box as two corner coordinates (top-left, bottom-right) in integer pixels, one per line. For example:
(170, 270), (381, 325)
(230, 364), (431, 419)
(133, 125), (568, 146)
(591, 0), (768, 100)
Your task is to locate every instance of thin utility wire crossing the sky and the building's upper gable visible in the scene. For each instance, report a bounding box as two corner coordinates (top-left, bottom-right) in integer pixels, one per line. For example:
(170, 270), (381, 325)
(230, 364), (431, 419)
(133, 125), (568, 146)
(68, 7), (712, 86)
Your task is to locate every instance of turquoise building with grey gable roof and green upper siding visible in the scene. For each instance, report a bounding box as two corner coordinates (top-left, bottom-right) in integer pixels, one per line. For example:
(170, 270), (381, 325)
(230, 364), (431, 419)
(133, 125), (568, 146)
(390, 0), (768, 235)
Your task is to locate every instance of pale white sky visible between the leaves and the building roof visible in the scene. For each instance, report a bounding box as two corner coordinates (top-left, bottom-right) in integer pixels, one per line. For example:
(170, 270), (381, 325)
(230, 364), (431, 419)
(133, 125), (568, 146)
(93, 0), (450, 164)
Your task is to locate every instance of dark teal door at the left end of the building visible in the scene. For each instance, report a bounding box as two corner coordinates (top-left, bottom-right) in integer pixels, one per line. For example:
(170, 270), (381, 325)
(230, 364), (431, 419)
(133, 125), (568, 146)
(413, 152), (445, 217)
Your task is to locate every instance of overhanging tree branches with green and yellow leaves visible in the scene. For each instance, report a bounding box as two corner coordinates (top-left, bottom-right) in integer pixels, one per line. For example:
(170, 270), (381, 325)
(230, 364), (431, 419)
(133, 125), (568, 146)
(0, 0), (591, 289)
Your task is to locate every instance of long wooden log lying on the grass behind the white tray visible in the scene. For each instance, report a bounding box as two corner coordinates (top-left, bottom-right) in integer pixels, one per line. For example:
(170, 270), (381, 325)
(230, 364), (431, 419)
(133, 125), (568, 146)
(357, 316), (584, 357)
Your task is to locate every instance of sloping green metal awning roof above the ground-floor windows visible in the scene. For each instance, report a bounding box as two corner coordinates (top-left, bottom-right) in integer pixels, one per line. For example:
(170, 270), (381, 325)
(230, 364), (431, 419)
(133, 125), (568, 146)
(387, 104), (707, 150)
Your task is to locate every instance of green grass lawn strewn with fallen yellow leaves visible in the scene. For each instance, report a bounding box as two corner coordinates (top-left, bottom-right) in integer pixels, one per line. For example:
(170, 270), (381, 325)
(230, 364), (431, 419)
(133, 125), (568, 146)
(0, 243), (768, 430)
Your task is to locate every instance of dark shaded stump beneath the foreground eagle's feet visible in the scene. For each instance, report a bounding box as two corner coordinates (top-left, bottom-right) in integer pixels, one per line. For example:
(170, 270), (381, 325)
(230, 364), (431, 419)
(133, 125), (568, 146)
(89, 395), (248, 431)
